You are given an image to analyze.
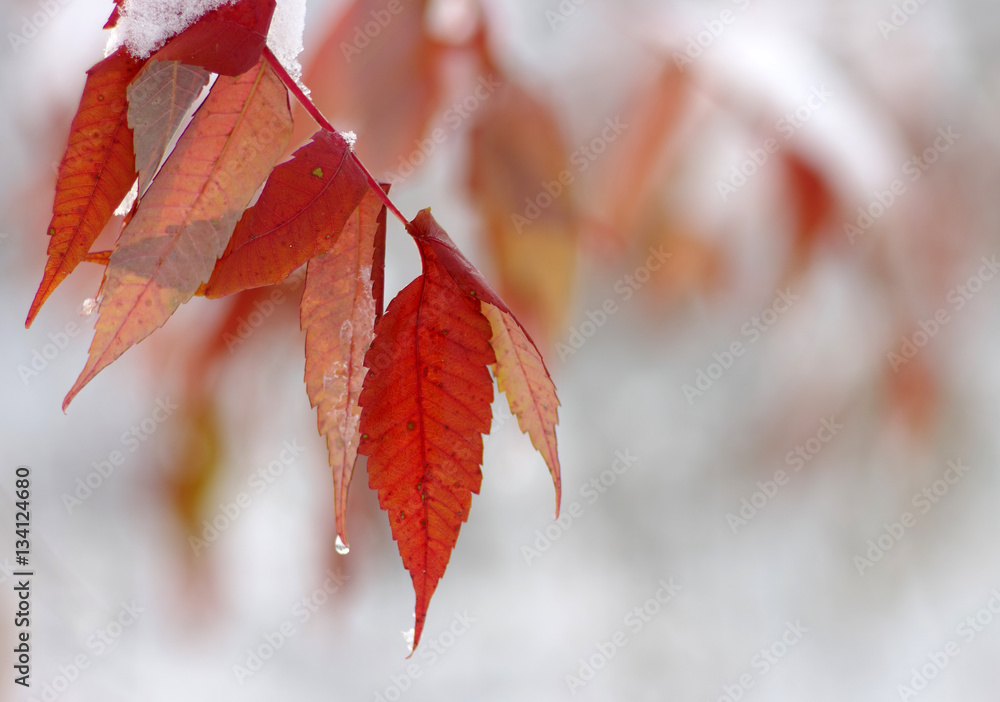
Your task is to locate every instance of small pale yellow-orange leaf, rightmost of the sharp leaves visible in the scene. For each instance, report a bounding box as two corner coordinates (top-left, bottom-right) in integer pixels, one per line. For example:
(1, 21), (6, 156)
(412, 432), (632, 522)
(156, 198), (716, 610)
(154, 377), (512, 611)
(482, 301), (562, 519)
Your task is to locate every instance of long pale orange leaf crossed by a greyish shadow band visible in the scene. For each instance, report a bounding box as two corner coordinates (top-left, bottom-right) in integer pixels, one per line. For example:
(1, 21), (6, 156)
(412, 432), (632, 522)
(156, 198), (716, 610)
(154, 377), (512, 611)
(63, 62), (292, 409)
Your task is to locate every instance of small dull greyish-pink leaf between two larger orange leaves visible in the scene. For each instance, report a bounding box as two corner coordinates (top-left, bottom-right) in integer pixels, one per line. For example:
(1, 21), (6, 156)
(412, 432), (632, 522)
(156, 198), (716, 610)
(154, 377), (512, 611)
(128, 60), (209, 193)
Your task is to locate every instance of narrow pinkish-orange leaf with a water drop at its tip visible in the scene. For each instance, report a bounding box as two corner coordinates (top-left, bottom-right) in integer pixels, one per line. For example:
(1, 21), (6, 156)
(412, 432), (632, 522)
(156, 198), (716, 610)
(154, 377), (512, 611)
(300, 184), (386, 544)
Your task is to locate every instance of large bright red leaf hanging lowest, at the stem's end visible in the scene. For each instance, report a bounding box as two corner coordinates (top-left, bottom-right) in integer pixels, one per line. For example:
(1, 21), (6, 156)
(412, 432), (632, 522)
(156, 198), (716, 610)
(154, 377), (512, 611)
(359, 234), (496, 649)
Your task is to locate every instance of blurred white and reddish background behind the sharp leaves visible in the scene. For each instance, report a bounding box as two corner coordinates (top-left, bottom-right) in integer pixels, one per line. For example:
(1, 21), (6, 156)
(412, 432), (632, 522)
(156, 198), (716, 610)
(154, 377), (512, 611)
(0, 0), (1000, 702)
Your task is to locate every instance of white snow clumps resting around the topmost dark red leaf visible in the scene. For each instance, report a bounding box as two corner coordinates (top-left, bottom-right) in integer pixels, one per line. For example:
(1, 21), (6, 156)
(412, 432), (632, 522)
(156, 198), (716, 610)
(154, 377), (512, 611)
(105, 0), (306, 81)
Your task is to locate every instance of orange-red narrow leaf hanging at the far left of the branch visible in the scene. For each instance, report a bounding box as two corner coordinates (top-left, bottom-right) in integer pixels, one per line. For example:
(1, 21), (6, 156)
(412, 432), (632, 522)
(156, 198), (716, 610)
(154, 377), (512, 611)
(25, 49), (143, 326)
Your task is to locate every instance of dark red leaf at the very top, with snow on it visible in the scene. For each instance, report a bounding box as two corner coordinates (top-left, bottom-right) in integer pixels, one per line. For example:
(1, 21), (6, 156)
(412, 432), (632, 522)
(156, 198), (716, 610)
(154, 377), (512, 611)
(157, 0), (276, 76)
